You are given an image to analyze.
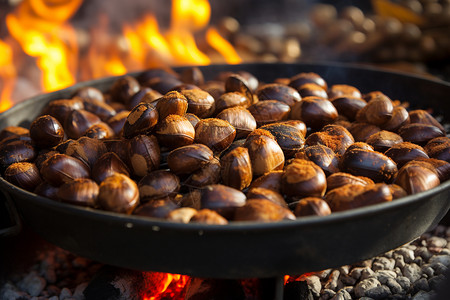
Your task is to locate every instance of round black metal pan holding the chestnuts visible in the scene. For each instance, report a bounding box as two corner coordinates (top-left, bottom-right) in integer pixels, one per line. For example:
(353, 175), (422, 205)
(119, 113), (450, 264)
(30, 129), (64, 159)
(0, 63), (450, 278)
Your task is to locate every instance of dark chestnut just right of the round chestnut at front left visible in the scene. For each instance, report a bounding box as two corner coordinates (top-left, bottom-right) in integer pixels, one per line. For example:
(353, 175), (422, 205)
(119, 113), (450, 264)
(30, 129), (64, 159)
(138, 170), (180, 202)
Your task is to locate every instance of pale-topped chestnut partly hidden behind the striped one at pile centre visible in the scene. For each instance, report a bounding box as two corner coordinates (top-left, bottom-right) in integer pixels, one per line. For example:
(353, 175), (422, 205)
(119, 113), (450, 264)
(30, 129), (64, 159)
(216, 106), (256, 139)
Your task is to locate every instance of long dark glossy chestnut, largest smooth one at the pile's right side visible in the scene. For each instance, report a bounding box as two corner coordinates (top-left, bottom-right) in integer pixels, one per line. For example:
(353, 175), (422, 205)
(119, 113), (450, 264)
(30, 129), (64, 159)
(341, 149), (397, 182)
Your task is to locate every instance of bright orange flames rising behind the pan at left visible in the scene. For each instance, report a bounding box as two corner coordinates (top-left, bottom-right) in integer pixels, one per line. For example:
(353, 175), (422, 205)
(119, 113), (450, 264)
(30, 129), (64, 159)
(0, 0), (241, 112)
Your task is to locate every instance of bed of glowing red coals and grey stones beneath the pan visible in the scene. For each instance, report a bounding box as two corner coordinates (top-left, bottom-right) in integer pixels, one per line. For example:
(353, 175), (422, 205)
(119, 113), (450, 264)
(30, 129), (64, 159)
(0, 224), (450, 300)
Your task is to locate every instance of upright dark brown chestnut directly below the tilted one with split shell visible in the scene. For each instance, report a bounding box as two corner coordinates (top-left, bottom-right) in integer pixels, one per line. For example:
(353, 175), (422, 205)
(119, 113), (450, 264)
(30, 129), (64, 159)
(127, 135), (161, 177)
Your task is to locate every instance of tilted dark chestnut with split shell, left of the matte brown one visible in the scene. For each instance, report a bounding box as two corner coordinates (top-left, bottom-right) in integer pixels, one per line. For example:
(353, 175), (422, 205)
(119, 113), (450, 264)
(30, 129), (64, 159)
(123, 103), (159, 138)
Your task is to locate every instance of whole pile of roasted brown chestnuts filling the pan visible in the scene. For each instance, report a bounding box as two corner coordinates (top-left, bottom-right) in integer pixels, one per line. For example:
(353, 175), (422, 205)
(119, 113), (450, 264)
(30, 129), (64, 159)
(0, 67), (450, 224)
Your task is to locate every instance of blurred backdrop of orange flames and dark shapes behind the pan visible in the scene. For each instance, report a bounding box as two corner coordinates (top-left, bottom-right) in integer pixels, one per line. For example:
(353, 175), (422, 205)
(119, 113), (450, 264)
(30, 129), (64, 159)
(0, 0), (450, 111)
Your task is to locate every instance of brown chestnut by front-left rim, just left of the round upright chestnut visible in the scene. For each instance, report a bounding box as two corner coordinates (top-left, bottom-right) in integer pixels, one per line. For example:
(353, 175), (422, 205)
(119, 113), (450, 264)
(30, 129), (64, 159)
(56, 178), (99, 207)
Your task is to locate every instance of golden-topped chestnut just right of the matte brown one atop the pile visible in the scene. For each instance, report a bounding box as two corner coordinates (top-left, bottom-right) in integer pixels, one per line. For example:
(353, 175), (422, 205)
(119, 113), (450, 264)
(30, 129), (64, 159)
(181, 89), (215, 118)
